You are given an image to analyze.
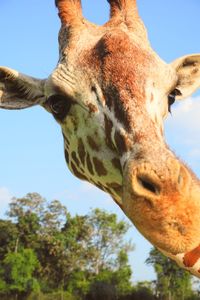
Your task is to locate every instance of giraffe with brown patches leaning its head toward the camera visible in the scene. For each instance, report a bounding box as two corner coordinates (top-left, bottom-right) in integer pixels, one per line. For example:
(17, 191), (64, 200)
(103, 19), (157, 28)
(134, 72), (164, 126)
(0, 0), (200, 277)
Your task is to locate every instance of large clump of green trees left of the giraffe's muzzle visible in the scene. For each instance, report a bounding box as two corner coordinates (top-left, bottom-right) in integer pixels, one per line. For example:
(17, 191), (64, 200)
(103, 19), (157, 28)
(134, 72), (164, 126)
(0, 193), (133, 299)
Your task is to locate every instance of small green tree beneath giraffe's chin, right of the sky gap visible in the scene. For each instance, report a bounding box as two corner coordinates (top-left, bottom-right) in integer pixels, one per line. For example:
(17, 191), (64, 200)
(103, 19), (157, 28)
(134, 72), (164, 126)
(146, 248), (192, 300)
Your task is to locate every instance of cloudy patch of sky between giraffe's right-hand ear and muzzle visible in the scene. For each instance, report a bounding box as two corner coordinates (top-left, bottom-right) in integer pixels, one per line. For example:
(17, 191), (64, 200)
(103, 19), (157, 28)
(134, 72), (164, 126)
(166, 96), (200, 173)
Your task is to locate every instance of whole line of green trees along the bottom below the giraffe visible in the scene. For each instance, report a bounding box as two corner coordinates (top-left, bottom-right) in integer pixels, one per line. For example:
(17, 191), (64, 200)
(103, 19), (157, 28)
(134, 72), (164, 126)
(0, 193), (200, 300)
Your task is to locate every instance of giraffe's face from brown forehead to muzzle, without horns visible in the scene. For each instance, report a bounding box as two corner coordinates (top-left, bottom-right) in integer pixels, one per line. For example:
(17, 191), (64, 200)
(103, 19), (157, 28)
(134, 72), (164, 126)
(44, 28), (200, 254)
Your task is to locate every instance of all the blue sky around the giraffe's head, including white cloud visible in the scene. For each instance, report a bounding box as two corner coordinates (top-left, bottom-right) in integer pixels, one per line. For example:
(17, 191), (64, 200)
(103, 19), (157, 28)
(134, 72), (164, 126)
(0, 0), (200, 281)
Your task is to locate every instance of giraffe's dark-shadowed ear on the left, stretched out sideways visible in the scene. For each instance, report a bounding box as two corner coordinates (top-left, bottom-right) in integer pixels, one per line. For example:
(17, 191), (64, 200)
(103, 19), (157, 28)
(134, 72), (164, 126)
(0, 67), (45, 109)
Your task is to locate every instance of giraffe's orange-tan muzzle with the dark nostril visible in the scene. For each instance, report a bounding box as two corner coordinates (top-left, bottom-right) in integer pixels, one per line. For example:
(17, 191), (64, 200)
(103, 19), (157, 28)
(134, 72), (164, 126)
(123, 157), (200, 255)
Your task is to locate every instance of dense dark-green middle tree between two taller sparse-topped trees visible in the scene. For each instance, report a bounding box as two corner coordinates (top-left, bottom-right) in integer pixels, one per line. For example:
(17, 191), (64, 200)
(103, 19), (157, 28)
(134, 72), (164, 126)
(37, 213), (91, 290)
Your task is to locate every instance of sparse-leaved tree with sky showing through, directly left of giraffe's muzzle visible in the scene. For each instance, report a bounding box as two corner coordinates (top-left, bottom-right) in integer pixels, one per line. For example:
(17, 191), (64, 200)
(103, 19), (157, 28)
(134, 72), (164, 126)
(82, 209), (133, 299)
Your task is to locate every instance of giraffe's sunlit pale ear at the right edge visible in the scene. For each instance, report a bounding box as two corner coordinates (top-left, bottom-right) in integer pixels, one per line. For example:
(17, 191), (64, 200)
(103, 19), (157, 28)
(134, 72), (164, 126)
(171, 54), (200, 99)
